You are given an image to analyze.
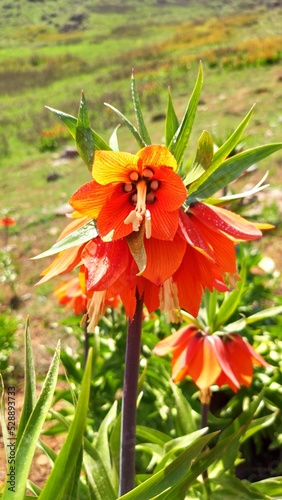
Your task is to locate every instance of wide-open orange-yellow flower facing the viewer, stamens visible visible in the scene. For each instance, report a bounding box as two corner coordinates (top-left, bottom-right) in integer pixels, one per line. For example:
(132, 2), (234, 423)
(70, 145), (187, 240)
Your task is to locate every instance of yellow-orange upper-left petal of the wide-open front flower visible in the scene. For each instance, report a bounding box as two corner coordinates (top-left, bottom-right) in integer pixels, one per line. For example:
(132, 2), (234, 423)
(92, 150), (138, 185)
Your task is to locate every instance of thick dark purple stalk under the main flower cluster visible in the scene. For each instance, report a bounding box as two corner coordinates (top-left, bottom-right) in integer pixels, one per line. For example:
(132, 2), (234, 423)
(119, 292), (143, 496)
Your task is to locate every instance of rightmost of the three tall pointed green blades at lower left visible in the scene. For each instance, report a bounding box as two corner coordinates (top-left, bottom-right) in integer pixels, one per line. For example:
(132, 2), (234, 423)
(39, 349), (92, 500)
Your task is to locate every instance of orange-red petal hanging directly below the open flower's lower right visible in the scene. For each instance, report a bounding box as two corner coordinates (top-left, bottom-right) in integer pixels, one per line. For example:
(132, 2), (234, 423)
(143, 234), (186, 286)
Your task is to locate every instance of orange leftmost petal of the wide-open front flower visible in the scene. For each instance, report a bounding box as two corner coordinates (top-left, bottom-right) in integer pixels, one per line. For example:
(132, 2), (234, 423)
(69, 181), (114, 219)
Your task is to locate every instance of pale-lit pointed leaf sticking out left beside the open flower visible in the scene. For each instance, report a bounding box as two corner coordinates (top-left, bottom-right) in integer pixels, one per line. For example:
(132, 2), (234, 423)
(33, 221), (98, 260)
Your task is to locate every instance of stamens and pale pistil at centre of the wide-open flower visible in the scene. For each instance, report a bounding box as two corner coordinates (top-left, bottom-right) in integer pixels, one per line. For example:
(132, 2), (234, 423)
(123, 168), (160, 238)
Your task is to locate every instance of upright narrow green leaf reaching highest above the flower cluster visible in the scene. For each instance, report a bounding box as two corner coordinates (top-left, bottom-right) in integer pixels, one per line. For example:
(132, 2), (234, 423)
(168, 64), (203, 166)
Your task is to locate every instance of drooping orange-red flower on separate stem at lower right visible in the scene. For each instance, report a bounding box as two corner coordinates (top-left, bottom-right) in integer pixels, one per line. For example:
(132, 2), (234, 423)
(153, 325), (268, 392)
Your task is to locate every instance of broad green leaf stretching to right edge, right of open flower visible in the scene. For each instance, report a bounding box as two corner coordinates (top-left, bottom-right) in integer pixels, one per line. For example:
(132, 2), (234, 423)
(187, 143), (282, 203)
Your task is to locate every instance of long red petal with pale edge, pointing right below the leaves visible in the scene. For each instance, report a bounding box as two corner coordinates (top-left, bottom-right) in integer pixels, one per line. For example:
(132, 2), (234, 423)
(189, 202), (262, 241)
